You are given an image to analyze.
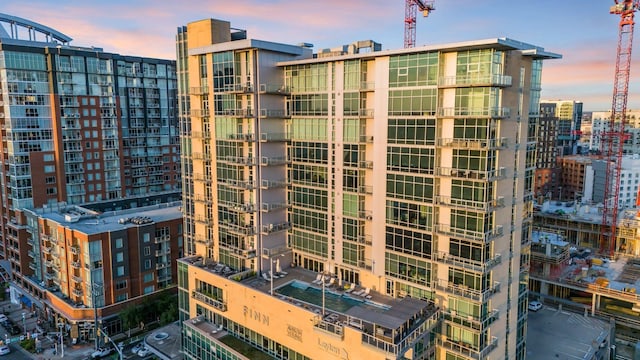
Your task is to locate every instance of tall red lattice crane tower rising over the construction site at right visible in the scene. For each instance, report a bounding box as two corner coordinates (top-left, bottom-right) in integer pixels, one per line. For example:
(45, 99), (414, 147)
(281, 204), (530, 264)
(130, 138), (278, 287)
(600, 0), (640, 257)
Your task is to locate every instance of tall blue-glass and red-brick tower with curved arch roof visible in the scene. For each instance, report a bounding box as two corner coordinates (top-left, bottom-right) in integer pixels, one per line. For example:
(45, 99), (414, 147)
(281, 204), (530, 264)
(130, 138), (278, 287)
(0, 14), (181, 276)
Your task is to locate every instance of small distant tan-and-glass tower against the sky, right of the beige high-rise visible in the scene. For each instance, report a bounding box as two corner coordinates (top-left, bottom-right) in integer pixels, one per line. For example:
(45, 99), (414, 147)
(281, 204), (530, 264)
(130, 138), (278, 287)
(541, 100), (583, 155)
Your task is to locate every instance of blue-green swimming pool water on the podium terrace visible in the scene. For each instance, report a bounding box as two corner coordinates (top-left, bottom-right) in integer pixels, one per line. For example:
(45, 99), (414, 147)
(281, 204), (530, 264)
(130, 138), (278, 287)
(276, 280), (380, 313)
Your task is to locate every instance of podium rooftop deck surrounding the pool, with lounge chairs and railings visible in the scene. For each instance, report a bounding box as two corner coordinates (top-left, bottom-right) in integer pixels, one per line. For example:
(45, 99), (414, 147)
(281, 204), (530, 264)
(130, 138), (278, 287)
(179, 257), (439, 354)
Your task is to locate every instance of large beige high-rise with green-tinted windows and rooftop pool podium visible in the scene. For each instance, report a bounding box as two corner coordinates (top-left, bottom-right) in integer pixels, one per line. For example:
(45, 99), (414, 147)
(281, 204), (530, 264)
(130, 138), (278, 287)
(176, 19), (559, 359)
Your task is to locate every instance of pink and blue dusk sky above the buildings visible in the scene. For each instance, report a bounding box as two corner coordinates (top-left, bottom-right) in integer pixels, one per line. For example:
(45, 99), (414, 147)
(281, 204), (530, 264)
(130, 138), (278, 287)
(0, 0), (640, 111)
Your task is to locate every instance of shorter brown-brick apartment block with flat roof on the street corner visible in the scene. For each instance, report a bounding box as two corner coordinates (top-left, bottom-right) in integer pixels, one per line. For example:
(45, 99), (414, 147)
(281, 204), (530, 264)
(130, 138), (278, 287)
(18, 202), (183, 340)
